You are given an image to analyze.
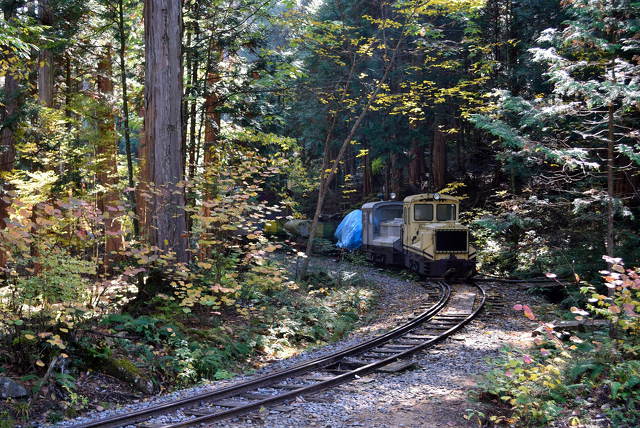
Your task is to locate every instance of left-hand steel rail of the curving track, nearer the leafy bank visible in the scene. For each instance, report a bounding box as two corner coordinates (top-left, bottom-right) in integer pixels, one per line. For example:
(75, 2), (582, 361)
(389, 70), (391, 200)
(71, 281), (451, 428)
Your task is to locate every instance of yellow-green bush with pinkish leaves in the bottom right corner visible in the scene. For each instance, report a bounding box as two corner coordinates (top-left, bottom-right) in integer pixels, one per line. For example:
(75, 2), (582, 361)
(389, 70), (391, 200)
(467, 258), (640, 426)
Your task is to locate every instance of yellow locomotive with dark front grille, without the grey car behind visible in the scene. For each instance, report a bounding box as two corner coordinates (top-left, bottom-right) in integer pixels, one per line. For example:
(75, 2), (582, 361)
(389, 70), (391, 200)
(402, 193), (476, 277)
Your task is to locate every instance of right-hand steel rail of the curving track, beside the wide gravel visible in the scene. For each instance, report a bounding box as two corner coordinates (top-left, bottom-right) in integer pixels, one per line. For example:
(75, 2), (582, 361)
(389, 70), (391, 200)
(163, 283), (486, 428)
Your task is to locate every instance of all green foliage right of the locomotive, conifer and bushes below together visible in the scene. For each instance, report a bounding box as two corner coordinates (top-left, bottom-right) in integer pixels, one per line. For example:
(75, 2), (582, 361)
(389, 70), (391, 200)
(471, 0), (640, 278)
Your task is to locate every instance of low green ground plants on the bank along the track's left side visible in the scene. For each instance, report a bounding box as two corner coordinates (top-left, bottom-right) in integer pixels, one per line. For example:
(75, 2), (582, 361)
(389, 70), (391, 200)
(92, 264), (373, 385)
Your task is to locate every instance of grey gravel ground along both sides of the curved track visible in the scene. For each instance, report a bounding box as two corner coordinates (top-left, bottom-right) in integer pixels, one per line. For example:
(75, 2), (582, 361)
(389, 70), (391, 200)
(47, 257), (546, 428)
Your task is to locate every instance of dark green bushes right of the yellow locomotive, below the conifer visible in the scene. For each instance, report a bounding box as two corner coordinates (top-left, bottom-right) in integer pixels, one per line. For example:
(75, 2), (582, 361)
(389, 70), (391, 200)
(468, 191), (640, 281)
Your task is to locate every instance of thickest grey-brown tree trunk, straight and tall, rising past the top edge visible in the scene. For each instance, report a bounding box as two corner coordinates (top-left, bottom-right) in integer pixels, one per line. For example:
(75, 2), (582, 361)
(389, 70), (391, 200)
(143, 0), (189, 262)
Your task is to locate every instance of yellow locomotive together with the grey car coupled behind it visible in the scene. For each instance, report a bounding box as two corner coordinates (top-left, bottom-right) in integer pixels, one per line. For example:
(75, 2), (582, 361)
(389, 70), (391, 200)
(362, 193), (476, 277)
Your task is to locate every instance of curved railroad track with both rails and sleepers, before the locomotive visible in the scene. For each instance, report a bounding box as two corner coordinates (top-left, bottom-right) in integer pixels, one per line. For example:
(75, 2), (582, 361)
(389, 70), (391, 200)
(73, 281), (486, 428)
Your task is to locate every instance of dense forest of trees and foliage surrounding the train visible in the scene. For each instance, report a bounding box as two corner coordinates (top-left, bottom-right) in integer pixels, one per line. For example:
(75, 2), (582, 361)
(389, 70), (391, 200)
(0, 0), (640, 424)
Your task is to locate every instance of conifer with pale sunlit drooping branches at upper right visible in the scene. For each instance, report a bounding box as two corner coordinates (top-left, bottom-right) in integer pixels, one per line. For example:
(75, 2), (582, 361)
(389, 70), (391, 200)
(474, 0), (640, 268)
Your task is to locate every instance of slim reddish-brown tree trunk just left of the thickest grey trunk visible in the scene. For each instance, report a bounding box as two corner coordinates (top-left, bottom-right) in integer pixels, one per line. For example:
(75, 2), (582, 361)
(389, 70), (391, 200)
(96, 46), (122, 267)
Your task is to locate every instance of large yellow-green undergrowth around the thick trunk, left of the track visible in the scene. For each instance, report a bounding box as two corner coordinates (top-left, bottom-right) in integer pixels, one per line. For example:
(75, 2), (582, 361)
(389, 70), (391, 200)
(0, 130), (318, 418)
